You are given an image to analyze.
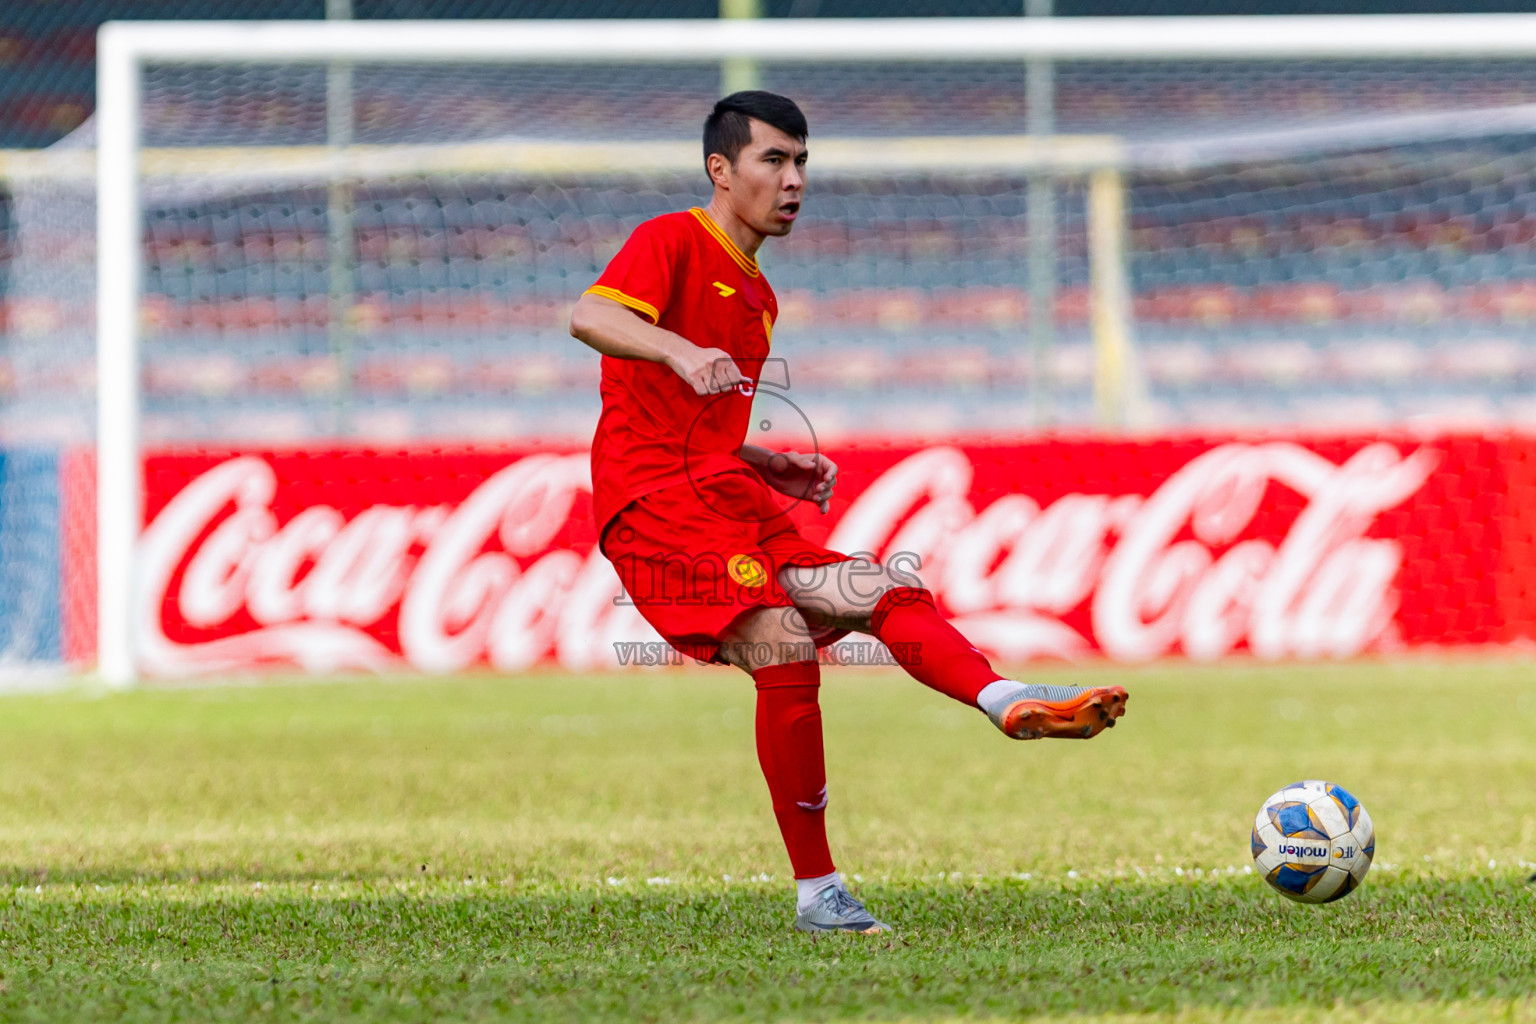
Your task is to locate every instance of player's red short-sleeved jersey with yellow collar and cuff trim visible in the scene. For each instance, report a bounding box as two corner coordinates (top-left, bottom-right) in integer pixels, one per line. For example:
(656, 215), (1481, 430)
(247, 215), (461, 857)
(588, 207), (779, 536)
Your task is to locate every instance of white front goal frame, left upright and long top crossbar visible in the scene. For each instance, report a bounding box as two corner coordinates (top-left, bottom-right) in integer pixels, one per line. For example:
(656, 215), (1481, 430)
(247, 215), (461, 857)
(95, 15), (1536, 686)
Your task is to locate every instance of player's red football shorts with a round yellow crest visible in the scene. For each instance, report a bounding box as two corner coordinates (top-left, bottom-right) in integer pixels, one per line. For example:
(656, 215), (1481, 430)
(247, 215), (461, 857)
(602, 470), (849, 665)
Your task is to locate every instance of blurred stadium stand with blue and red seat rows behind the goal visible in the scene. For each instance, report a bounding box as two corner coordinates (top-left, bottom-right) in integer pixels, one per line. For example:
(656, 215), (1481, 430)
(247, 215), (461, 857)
(0, 0), (1536, 441)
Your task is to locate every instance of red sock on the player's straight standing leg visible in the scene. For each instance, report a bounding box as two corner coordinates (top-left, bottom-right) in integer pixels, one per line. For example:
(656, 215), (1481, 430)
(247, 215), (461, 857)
(753, 662), (836, 878)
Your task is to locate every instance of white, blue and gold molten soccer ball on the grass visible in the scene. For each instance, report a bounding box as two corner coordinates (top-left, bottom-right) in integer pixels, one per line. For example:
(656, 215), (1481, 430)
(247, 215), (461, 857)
(1253, 778), (1376, 903)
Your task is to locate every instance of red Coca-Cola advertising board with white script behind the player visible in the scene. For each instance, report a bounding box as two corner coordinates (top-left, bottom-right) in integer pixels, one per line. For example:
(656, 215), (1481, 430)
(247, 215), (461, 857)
(63, 436), (1536, 676)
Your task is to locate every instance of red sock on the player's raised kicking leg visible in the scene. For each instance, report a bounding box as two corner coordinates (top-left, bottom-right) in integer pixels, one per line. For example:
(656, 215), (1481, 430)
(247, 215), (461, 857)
(869, 586), (1001, 708)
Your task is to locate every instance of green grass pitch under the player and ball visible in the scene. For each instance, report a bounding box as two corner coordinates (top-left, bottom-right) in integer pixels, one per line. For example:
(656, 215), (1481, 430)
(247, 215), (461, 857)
(0, 663), (1536, 1024)
